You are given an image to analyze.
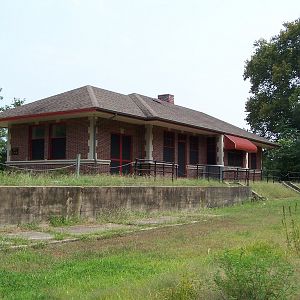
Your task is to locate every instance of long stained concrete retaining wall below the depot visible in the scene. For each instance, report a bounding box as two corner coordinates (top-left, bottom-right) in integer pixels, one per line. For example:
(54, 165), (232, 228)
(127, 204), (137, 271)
(0, 186), (251, 224)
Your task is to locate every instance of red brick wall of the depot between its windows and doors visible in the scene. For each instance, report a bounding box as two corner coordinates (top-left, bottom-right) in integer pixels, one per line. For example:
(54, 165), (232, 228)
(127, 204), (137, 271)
(10, 118), (262, 172)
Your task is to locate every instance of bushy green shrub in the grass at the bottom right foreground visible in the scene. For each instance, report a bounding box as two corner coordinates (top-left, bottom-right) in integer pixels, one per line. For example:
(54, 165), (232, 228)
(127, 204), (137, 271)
(214, 243), (293, 300)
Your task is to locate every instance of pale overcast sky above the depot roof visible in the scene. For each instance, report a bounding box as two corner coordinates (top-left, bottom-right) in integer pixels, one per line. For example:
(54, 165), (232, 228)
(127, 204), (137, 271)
(0, 0), (300, 128)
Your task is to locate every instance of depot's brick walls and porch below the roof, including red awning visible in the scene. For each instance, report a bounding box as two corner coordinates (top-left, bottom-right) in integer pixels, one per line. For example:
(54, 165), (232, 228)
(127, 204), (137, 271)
(6, 116), (263, 182)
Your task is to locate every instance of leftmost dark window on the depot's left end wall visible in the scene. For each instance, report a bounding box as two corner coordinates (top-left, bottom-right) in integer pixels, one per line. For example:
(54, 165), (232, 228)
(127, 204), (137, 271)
(30, 126), (45, 160)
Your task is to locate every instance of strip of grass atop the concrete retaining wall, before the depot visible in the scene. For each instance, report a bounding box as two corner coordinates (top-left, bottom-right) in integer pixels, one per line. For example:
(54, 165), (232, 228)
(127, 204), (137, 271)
(0, 172), (224, 186)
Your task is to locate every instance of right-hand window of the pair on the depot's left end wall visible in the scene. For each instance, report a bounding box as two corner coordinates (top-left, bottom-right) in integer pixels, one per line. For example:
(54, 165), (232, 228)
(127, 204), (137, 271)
(50, 124), (66, 159)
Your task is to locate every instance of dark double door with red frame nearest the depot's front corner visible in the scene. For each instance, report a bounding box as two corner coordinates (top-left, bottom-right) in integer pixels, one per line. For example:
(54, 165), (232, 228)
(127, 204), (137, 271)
(110, 134), (132, 175)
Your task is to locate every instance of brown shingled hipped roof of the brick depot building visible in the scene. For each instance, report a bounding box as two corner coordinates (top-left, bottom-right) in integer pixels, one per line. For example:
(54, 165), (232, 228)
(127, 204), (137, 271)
(0, 85), (275, 146)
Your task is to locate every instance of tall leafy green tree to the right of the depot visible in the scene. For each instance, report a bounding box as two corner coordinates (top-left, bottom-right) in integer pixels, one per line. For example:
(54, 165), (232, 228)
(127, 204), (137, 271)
(244, 19), (300, 140)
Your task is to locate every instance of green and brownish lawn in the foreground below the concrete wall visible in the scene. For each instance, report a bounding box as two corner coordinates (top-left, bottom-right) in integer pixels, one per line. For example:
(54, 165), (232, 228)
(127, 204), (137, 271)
(0, 196), (300, 299)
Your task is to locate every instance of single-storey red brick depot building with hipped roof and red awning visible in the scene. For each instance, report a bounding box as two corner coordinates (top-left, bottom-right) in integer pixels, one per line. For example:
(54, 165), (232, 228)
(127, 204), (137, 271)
(0, 86), (275, 176)
